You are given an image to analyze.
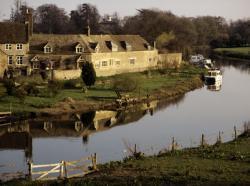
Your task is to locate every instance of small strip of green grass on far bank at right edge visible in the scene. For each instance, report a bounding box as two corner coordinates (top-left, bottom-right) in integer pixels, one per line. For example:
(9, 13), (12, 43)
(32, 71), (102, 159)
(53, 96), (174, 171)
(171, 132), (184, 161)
(214, 47), (250, 60)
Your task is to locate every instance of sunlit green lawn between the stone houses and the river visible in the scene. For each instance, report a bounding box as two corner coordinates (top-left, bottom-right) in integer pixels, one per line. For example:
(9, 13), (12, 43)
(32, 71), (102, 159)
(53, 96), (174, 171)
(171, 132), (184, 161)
(0, 65), (202, 115)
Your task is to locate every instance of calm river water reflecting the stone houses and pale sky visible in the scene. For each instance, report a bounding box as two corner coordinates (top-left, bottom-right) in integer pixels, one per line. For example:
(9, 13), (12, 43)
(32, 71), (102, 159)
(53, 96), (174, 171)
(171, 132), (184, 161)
(0, 61), (250, 176)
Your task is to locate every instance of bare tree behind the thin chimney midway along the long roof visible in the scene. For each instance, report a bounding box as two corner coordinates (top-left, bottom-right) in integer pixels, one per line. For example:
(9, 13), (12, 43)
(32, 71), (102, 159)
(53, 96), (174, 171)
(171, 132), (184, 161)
(70, 4), (101, 34)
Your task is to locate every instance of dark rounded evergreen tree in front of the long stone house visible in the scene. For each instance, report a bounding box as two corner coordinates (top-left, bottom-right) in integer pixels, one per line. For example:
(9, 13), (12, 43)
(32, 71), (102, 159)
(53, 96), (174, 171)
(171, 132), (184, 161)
(81, 61), (96, 87)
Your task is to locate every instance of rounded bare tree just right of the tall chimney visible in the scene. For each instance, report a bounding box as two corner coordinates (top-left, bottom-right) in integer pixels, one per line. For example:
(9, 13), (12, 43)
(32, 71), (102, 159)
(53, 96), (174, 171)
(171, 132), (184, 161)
(34, 4), (69, 34)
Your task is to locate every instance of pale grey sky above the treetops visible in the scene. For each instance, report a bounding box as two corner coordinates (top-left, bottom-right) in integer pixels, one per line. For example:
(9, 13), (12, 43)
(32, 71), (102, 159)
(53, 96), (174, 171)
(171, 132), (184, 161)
(0, 0), (250, 20)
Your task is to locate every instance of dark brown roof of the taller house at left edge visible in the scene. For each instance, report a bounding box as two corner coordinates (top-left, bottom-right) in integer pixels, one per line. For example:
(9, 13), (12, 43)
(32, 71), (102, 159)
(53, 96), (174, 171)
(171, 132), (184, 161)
(0, 22), (28, 44)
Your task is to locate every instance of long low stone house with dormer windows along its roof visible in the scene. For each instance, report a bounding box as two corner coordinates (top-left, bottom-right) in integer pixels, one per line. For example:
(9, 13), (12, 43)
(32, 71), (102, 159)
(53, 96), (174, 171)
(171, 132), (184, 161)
(29, 34), (158, 79)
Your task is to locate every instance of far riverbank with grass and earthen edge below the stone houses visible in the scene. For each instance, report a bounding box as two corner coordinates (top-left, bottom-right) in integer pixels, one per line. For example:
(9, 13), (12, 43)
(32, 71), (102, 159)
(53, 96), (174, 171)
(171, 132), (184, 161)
(0, 65), (203, 115)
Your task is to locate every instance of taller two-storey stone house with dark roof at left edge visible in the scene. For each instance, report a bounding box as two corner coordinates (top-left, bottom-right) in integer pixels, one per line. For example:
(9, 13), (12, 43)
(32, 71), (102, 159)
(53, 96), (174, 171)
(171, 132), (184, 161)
(0, 22), (29, 77)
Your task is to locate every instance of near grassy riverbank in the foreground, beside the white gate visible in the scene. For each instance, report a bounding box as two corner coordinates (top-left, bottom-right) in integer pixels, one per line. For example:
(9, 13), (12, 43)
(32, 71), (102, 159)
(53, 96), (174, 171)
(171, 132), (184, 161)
(6, 129), (250, 185)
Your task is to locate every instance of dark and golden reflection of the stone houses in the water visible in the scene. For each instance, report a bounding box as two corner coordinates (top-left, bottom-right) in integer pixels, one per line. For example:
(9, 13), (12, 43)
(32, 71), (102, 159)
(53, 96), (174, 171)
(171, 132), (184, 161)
(0, 101), (158, 159)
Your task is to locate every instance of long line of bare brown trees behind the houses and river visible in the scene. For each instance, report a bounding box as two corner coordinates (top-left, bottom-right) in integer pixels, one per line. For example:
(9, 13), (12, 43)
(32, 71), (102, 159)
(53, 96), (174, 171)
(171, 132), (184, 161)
(7, 0), (250, 57)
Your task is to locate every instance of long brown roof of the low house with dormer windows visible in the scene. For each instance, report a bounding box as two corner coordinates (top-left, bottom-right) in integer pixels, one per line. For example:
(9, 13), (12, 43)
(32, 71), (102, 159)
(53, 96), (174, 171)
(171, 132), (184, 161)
(30, 34), (149, 55)
